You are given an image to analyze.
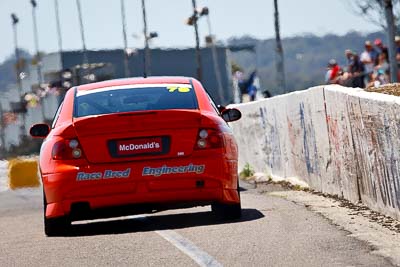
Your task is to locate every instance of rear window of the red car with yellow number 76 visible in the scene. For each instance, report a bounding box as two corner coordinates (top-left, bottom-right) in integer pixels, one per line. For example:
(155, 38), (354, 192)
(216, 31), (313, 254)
(74, 84), (198, 117)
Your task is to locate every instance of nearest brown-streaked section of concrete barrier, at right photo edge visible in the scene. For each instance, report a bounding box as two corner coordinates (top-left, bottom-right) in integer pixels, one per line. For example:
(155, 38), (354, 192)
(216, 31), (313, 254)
(349, 92), (400, 221)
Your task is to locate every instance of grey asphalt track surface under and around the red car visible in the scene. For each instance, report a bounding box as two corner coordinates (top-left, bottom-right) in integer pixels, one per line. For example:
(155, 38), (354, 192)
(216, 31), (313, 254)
(0, 183), (391, 267)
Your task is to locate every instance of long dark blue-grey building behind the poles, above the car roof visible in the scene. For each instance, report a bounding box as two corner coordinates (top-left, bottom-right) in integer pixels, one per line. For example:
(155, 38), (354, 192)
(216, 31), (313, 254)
(23, 47), (233, 104)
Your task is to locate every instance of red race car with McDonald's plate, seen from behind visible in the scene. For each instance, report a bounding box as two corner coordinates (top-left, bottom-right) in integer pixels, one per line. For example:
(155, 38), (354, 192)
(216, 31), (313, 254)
(30, 77), (241, 236)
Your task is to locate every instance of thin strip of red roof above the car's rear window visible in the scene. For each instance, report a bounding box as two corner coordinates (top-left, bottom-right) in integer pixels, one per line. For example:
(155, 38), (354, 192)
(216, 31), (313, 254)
(77, 76), (193, 91)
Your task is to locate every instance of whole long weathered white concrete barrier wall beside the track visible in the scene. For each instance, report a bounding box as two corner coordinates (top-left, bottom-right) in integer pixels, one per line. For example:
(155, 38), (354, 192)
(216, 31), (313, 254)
(231, 86), (400, 218)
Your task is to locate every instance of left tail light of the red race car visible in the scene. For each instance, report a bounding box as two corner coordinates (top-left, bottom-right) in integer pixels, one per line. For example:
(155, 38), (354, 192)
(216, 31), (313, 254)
(51, 139), (83, 160)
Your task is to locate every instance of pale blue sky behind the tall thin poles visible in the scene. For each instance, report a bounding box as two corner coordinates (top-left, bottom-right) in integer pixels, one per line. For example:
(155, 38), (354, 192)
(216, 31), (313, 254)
(0, 0), (379, 63)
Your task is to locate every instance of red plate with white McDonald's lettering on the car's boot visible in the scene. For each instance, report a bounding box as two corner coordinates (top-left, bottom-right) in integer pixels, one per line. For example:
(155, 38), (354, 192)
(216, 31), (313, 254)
(117, 137), (162, 155)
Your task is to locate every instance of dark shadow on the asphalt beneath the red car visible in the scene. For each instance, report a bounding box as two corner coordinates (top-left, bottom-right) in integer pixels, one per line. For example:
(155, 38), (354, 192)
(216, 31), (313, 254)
(65, 209), (264, 239)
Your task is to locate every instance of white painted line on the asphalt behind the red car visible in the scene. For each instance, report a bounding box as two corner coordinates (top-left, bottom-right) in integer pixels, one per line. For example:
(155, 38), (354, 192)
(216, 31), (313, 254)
(155, 230), (222, 267)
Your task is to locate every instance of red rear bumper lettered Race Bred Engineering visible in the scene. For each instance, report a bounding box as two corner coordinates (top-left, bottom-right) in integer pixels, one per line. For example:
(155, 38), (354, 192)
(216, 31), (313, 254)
(42, 156), (240, 218)
